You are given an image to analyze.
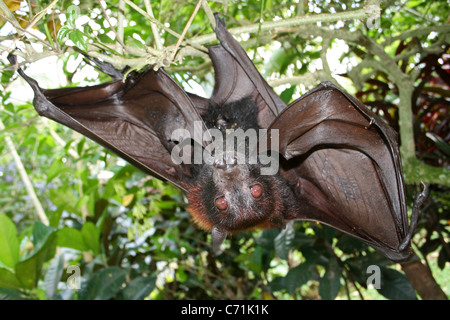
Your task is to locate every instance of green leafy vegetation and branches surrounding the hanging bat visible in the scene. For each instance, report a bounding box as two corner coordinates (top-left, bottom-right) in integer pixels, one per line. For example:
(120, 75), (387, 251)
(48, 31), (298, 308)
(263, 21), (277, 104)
(0, 0), (450, 299)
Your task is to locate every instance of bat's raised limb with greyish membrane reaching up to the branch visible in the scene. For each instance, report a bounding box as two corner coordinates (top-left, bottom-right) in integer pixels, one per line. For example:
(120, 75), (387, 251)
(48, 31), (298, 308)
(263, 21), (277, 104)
(208, 14), (286, 128)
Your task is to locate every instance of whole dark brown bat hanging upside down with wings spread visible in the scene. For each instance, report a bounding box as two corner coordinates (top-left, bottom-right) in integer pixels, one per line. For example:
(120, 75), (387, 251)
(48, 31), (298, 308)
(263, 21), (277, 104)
(10, 15), (426, 261)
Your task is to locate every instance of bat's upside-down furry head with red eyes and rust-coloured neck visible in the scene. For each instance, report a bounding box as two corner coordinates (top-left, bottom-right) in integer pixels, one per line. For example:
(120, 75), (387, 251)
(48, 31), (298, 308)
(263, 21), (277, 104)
(187, 151), (290, 253)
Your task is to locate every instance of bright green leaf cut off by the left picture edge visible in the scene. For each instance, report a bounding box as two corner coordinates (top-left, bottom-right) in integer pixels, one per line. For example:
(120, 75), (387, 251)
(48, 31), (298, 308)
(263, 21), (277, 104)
(0, 214), (20, 269)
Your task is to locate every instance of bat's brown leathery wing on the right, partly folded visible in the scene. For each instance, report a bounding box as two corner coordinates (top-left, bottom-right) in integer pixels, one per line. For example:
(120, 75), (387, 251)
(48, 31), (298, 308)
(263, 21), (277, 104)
(269, 83), (409, 260)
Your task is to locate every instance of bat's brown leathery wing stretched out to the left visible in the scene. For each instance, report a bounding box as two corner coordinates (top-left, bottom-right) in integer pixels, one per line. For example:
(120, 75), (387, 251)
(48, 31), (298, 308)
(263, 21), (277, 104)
(14, 59), (206, 190)
